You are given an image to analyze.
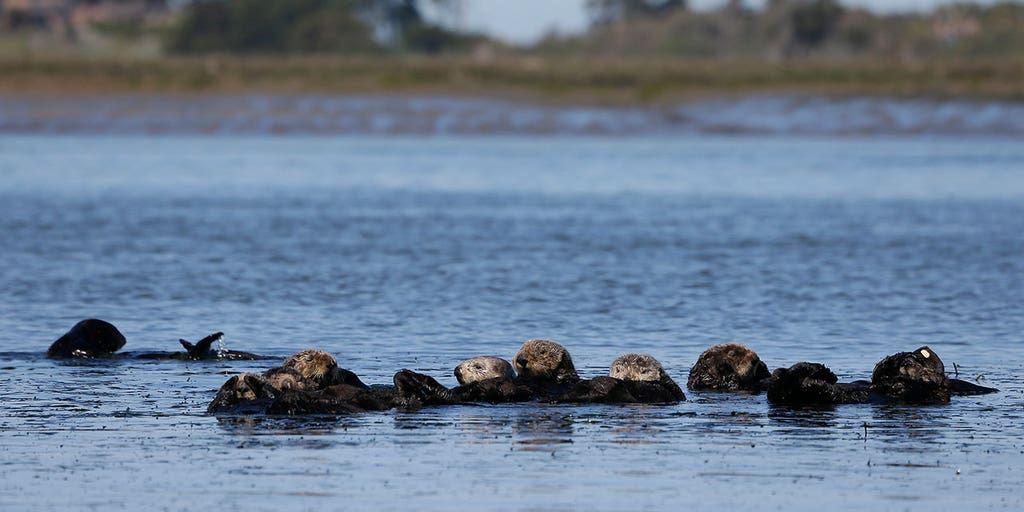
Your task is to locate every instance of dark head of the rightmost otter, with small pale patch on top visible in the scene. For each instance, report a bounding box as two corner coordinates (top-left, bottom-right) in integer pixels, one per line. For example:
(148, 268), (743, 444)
(871, 346), (949, 402)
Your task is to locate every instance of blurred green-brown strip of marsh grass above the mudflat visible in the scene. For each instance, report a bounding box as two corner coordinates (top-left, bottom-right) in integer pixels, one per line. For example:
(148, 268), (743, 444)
(0, 55), (1024, 106)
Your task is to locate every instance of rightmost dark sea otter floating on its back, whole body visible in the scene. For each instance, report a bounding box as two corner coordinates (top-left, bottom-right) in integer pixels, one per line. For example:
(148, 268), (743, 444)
(768, 346), (998, 406)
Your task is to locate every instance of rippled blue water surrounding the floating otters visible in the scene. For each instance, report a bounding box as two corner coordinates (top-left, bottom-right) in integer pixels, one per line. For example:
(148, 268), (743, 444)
(0, 135), (1024, 510)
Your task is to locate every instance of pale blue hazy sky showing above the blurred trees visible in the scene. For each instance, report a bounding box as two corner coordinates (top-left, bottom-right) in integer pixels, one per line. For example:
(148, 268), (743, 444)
(440, 0), (1015, 43)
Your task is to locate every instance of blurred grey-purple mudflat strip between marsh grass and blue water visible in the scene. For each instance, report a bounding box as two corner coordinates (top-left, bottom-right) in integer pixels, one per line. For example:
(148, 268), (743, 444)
(0, 92), (1024, 136)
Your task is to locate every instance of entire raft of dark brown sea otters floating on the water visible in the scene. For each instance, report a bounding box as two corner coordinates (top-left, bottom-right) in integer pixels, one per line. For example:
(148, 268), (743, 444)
(47, 318), (998, 415)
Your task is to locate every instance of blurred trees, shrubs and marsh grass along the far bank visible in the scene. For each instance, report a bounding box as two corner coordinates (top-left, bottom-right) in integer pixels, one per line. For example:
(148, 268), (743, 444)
(0, 0), (1024, 102)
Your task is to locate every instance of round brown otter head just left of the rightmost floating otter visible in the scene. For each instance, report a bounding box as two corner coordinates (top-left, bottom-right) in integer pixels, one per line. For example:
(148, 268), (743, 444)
(686, 343), (771, 393)
